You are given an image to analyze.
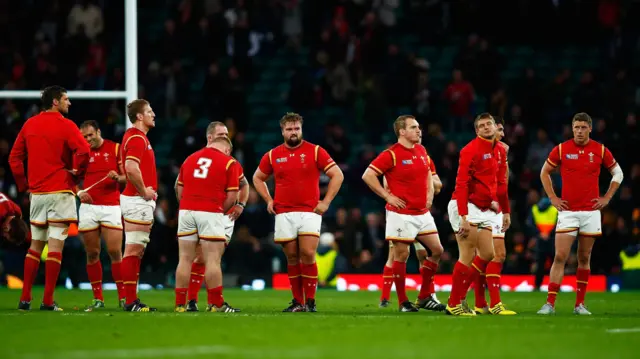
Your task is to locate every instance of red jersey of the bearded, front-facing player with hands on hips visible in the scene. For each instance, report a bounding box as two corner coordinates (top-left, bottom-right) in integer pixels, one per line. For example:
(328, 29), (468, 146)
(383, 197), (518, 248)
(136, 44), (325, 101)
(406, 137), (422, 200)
(259, 141), (336, 214)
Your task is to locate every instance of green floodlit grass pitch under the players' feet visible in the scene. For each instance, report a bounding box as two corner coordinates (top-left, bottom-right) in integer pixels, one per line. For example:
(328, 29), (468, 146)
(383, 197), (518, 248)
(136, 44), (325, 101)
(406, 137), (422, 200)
(0, 288), (640, 359)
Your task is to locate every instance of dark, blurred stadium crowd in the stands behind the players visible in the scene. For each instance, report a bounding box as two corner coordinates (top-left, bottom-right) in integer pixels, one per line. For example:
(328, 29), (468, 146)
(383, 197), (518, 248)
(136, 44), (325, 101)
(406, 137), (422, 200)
(0, 0), (640, 284)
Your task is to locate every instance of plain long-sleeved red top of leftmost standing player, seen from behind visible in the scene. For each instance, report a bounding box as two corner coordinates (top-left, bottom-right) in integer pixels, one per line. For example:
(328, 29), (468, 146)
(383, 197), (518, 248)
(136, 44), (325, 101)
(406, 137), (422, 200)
(20, 112), (89, 194)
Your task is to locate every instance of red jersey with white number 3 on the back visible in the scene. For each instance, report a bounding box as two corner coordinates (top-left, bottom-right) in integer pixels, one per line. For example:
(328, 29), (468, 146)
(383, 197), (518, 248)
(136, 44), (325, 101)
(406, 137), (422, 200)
(178, 147), (241, 213)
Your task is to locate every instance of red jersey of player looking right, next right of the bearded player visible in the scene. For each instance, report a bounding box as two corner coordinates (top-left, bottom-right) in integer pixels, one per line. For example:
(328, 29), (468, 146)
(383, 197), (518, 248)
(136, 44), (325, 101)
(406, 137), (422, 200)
(369, 143), (432, 215)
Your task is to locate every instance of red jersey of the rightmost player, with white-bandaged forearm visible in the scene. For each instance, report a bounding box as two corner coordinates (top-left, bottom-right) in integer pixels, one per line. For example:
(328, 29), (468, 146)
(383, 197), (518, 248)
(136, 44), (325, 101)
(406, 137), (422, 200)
(547, 139), (617, 211)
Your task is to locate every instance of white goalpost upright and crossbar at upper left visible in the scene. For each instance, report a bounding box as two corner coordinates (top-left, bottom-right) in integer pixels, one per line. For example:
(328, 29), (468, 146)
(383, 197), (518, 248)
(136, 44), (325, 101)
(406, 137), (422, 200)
(0, 0), (138, 128)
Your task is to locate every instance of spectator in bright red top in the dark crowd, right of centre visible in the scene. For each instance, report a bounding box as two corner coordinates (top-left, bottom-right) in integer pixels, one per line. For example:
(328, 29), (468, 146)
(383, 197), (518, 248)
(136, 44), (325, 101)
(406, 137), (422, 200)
(442, 69), (476, 132)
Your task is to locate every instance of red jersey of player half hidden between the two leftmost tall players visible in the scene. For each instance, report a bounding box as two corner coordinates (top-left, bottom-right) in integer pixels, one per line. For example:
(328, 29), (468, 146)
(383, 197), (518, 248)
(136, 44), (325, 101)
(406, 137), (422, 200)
(84, 140), (121, 206)
